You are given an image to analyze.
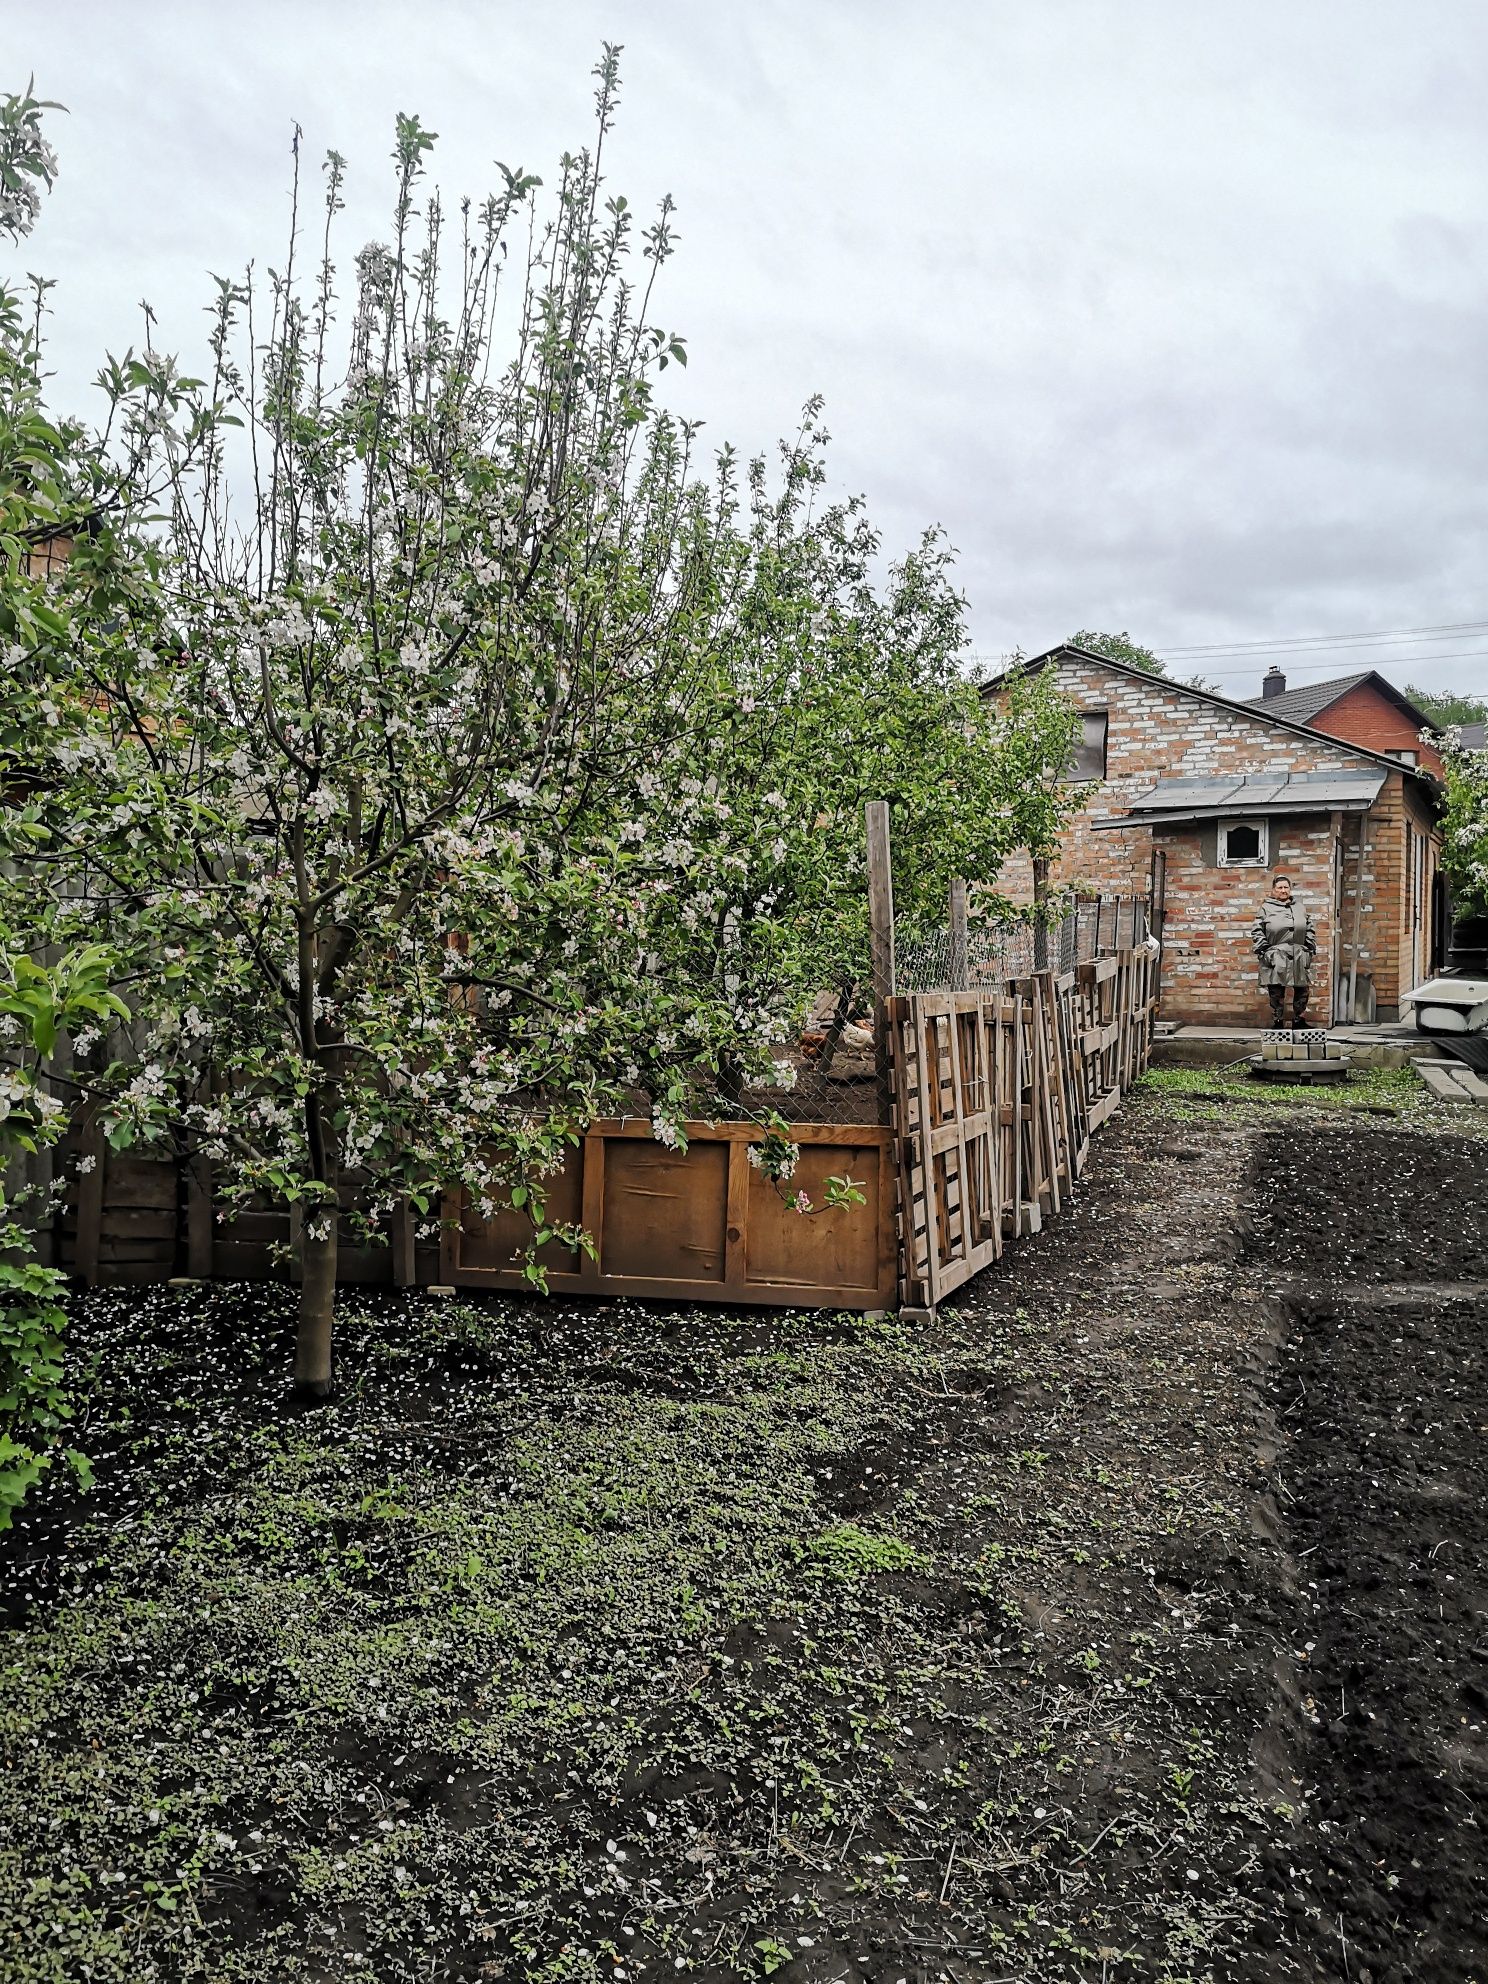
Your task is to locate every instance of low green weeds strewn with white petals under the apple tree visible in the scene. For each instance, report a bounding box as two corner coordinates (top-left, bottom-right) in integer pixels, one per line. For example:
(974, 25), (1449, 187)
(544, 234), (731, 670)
(0, 1288), (968, 1984)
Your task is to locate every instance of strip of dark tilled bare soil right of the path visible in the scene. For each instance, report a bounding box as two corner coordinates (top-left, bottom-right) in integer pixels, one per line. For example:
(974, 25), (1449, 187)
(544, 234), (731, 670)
(1250, 1125), (1488, 1984)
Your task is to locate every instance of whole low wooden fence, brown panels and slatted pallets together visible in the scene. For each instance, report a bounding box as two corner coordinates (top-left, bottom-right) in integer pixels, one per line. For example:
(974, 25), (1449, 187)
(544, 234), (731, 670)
(46, 948), (1157, 1309)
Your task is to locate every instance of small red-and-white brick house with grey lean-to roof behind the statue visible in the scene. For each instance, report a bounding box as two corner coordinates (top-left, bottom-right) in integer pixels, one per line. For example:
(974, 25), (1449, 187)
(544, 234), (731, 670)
(986, 647), (1442, 1026)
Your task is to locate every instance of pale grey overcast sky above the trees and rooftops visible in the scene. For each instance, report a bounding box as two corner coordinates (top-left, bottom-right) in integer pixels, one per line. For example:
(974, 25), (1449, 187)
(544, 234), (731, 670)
(11, 0), (1488, 696)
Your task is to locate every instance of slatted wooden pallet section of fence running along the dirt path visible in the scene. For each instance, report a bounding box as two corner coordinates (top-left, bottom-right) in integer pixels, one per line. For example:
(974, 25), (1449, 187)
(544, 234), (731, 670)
(887, 946), (1155, 1309)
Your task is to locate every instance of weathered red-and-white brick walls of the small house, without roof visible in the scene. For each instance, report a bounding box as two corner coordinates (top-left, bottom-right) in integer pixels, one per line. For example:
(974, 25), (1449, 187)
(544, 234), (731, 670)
(1000, 655), (1440, 1026)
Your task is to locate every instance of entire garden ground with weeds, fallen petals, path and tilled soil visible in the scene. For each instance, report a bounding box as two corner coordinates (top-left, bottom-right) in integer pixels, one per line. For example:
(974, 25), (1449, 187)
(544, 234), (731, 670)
(0, 1091), (1488, 1984)
